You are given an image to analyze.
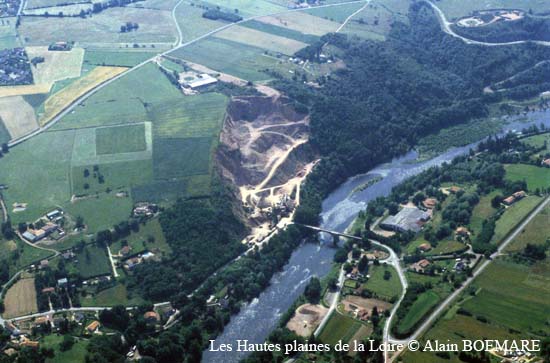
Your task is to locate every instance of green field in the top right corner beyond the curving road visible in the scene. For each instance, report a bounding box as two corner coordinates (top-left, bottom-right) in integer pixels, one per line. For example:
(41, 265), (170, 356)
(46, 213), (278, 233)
(437, 0), (550, 20)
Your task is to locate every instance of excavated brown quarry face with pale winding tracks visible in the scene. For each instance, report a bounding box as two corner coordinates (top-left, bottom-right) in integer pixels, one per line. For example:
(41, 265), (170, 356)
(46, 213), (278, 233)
(217, 96), (311, 187)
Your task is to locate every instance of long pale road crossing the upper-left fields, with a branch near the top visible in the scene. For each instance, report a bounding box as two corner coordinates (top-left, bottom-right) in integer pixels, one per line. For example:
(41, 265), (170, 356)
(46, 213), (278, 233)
(8, 0), (365, 147)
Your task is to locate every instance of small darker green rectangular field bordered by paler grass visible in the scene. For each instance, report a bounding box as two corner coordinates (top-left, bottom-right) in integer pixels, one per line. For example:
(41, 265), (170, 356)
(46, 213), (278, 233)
(95, 124), (147, 155)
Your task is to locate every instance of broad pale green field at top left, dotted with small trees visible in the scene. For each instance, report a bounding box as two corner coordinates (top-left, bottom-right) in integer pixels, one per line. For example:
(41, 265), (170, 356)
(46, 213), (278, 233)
(19, 7), (176, 48)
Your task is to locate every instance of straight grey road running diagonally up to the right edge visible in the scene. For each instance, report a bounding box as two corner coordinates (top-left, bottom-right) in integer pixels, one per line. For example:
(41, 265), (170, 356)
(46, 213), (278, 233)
(384, 196), (550, 362)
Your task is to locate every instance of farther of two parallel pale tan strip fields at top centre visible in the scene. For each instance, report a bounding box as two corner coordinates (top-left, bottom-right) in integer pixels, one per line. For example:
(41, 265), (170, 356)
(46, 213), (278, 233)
(257, 12), (340, 36)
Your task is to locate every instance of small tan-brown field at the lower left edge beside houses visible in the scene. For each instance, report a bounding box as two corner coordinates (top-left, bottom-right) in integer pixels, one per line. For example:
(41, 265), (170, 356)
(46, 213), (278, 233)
(3, 279), (38, 318)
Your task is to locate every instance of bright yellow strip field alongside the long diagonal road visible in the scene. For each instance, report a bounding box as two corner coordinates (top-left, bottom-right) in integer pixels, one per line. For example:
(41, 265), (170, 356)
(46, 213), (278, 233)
(39, 67), (127, 126)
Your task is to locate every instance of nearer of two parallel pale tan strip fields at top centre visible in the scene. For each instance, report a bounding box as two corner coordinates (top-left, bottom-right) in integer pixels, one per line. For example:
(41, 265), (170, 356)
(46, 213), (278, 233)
(214, 24), (308, 55)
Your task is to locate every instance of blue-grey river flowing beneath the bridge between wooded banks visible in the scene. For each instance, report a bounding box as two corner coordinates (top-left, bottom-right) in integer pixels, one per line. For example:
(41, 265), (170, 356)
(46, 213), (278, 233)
(202, 111), (550, 363)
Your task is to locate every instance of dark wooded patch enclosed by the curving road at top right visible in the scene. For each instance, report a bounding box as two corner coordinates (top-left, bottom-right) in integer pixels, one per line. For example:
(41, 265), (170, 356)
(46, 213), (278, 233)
(453, 16), (550, 43)
